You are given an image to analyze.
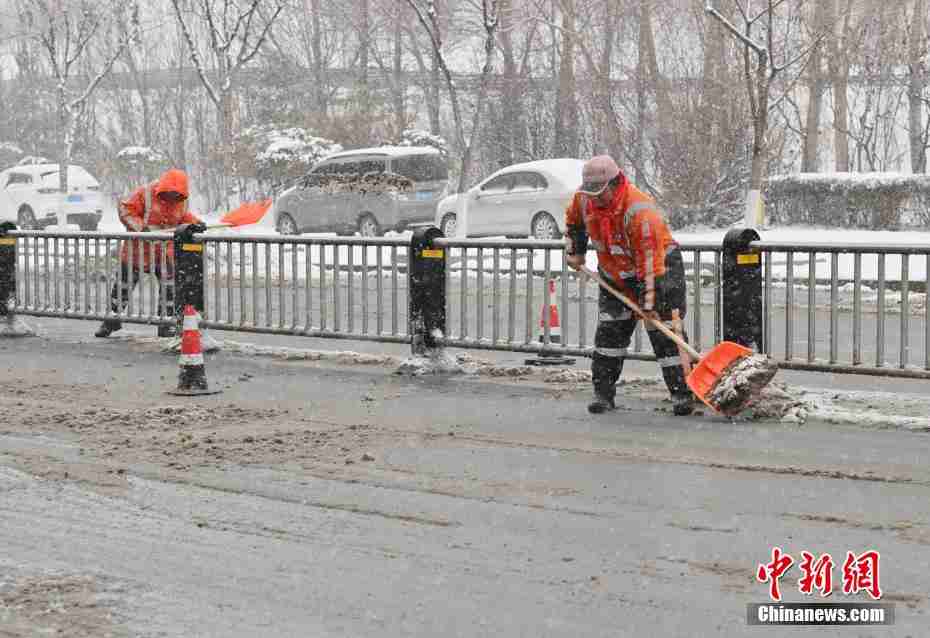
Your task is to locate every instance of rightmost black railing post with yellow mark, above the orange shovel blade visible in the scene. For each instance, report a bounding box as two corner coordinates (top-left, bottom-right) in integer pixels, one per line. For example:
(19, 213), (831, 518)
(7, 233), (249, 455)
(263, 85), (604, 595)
(722, 228), (764, 352)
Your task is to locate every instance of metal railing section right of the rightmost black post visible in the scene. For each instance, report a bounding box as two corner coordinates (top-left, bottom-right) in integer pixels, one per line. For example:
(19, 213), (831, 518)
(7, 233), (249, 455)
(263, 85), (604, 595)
(752, 241), (930, 378)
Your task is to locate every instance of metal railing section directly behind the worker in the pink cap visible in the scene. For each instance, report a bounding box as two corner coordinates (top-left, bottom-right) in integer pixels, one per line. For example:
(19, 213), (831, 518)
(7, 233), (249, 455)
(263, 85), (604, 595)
(435, 238), (721, 360)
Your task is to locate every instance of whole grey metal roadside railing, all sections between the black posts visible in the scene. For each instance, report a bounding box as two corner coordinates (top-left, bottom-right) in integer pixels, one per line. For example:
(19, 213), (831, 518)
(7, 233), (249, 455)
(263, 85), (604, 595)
(1, 231), (930, 378)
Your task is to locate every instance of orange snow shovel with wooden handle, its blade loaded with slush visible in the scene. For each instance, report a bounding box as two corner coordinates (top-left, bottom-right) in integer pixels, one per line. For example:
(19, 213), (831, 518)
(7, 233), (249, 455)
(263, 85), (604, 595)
(580, 266), (778, 416)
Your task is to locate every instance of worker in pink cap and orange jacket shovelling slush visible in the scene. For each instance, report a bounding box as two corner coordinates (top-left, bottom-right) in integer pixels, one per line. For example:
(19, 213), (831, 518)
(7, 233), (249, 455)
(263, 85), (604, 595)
(565, 155), (695, 416)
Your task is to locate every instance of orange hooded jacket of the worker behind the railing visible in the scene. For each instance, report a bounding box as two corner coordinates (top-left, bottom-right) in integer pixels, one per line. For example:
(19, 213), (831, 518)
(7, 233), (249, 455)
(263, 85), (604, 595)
(119, 168), (200, 276)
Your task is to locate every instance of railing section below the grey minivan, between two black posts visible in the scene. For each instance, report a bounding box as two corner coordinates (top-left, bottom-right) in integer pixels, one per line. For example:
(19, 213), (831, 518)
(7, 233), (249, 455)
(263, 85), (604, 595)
(199, 234), (410, 343)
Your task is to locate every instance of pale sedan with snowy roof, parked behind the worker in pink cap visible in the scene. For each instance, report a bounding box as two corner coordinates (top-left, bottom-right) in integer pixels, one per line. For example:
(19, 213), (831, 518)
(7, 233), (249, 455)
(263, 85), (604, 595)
(436, 158), (584, 239)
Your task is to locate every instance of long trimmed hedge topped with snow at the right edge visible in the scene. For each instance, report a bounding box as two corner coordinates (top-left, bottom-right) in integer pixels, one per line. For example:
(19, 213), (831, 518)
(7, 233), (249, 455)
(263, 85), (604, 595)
(764, 173), (930, 230)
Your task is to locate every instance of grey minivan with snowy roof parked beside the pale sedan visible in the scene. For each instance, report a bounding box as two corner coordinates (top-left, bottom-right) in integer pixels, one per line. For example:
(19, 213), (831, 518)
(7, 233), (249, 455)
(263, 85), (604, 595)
(274, 146), (449, 237)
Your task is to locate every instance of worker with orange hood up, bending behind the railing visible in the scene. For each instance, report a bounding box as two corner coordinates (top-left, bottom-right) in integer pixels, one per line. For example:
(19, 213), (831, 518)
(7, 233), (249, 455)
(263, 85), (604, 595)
(95, 168), (202, 337)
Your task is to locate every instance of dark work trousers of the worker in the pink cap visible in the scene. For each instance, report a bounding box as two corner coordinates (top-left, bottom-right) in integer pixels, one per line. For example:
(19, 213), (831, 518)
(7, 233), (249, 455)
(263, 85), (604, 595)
(591, 248), (690, 399)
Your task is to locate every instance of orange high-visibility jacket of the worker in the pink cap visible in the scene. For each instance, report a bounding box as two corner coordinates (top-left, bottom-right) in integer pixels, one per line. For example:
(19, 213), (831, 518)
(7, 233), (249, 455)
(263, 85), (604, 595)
(565, 179), (678, 310)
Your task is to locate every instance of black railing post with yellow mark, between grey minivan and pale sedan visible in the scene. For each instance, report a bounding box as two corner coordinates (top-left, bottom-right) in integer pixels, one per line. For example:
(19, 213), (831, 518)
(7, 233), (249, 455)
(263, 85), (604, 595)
(407, 226), (446, 355)
